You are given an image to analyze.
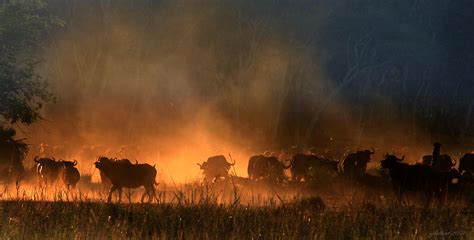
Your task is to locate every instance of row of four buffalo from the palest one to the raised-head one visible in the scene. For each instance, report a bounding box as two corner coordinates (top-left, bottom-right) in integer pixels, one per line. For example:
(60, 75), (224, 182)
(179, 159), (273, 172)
(198, 150), (374, 184)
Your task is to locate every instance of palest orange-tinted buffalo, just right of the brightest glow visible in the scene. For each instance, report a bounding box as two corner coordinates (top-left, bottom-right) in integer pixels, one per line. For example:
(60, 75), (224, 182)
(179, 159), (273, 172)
(198, 155), (235, 182)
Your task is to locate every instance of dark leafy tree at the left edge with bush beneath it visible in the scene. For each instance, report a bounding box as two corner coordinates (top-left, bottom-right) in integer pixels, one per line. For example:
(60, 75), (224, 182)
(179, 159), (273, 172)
(0, 0), (63, 180)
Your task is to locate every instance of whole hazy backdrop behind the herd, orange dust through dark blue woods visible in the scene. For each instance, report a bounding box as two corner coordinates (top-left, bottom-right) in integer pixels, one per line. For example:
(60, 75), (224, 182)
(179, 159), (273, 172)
(17, 0), (474, 179)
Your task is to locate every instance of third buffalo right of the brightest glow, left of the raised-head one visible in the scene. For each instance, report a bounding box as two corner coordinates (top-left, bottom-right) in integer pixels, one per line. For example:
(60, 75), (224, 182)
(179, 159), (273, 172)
(291, 154), (339, 182)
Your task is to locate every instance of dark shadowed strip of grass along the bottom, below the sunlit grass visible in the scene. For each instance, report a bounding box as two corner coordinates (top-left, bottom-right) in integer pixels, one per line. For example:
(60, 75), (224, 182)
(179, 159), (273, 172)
(0, 198), (474, 239)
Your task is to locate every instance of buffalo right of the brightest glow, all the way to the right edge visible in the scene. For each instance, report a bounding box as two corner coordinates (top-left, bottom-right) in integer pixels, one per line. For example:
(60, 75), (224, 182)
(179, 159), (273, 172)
(200, 143), (474, 204)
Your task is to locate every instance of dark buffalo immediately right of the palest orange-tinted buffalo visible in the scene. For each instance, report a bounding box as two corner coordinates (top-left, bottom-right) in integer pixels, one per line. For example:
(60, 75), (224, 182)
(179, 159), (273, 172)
(247, 155), (291, 182)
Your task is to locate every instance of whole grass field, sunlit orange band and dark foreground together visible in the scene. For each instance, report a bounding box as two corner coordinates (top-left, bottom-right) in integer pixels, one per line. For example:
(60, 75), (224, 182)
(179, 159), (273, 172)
(0, 181), (474, 239)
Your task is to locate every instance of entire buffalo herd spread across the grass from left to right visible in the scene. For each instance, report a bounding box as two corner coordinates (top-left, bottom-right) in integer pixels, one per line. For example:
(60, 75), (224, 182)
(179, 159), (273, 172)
(21, 143), (474, 203)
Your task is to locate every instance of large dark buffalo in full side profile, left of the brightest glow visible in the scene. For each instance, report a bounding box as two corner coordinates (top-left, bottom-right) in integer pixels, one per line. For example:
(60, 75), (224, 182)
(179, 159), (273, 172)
(94, 157), (158, 202)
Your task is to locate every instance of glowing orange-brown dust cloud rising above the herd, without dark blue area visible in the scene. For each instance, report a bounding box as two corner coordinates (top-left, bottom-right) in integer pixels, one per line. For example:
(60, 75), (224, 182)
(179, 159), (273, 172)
(17, 0), (440, 182)
